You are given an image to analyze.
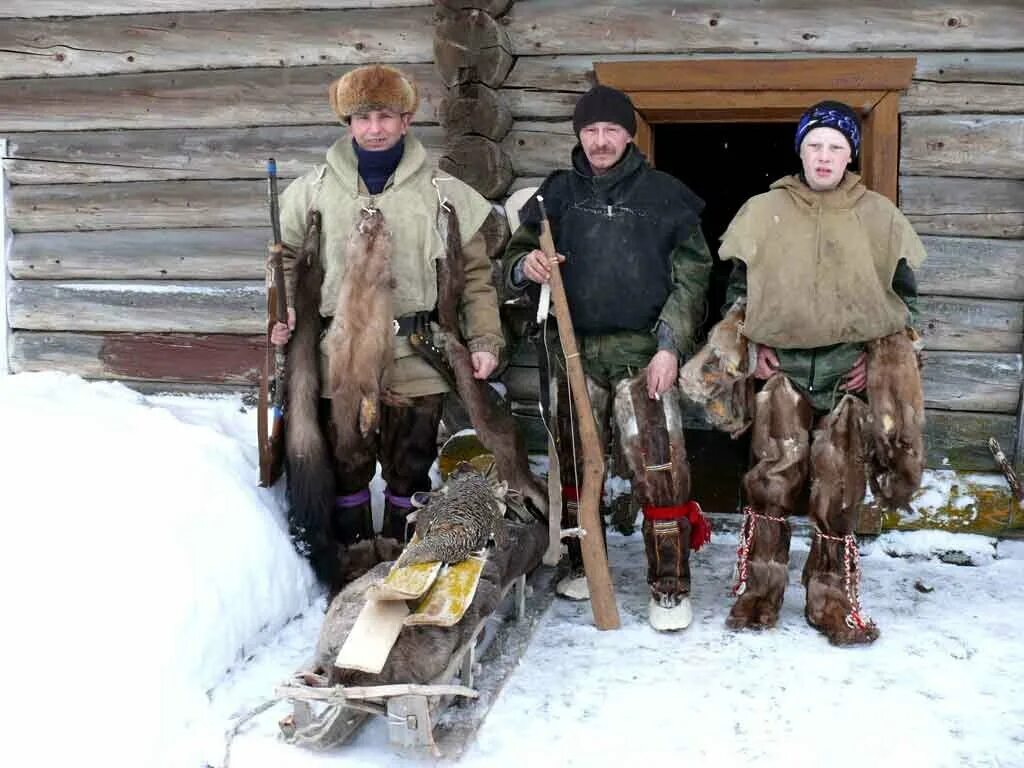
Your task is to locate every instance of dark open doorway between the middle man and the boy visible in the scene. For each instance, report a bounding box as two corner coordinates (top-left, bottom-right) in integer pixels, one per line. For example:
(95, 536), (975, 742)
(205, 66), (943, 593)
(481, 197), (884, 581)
(652, 123), (800, 512)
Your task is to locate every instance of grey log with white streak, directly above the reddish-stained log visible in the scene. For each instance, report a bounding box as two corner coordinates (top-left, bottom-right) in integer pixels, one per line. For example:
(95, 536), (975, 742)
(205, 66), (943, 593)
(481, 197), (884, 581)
(7, 280), (266, 334)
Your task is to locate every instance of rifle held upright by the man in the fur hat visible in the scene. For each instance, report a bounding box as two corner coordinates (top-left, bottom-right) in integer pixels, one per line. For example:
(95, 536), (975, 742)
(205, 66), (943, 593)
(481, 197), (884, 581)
(256, 158), (288, 487)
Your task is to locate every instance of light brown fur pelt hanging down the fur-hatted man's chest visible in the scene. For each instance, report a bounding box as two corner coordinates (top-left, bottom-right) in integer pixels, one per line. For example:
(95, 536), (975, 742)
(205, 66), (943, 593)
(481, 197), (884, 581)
(327, 210), (394, 473)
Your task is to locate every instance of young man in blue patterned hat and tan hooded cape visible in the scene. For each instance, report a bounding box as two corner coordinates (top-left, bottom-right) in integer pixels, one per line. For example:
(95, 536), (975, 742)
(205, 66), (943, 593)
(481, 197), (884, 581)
(719, 101), (925, 645)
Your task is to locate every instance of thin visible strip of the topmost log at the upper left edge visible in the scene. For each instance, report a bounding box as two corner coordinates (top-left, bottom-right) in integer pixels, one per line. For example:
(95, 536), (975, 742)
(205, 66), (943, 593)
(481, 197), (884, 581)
(0, 0), (432, 18)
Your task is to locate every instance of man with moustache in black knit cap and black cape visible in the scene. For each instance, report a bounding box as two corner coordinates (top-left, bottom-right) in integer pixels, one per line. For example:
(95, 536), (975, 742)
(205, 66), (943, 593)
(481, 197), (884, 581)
(506, 85), (712, 630)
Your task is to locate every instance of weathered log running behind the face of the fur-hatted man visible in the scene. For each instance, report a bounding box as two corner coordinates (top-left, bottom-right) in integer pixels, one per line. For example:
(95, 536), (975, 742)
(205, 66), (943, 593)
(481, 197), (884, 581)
(5, 124), (444, 184)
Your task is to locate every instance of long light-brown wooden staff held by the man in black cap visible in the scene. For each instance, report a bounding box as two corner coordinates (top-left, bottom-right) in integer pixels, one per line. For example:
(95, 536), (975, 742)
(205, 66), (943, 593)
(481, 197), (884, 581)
(537, 197), (620, 630)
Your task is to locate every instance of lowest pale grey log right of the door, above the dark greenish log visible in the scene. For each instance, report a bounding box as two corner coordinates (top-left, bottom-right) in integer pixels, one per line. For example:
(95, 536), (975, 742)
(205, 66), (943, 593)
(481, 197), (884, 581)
(922, 352), (1021, 415)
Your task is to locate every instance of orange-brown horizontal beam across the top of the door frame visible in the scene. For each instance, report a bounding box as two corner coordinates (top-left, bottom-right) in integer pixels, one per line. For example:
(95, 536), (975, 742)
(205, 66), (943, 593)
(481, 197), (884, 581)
(594, 57), (915, 92)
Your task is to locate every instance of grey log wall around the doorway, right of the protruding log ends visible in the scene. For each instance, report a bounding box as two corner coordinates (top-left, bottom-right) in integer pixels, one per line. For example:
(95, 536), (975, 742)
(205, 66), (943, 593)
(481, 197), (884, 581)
(465, 0), (1024, 469)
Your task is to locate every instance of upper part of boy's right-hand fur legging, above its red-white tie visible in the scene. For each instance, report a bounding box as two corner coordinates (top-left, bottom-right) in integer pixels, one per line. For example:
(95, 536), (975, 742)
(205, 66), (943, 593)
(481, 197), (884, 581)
(809, 394), (867, 536)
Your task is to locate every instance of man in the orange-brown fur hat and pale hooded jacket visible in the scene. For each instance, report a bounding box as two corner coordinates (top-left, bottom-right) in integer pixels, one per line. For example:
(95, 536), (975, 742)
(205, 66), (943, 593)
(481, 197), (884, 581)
(271, 65), (504, 581)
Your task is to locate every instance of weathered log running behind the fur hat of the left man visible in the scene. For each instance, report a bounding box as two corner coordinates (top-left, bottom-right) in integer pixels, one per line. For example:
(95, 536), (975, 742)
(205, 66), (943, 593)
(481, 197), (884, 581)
(0, 63), (445, 133)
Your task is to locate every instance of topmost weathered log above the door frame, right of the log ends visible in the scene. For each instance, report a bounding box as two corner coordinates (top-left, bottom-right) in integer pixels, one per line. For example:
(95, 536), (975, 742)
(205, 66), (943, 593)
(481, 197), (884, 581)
(507, 0), (1024, 55)
